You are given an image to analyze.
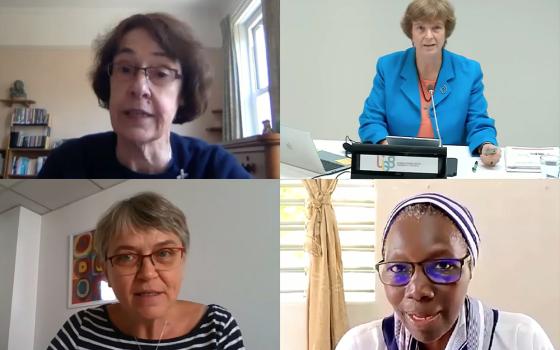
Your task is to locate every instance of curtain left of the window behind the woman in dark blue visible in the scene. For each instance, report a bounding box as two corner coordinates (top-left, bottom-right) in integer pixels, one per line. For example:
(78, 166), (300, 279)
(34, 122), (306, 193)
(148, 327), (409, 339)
(220, 15), (243, 142)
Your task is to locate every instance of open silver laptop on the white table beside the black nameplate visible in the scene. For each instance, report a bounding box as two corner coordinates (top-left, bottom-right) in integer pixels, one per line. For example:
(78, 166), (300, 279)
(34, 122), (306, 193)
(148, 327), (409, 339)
(280, 126), (350, 175)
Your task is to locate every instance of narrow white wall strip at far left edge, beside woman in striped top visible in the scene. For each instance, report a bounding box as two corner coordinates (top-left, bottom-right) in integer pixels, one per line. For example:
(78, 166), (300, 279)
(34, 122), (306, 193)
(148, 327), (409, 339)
(0, 207), (20, 349)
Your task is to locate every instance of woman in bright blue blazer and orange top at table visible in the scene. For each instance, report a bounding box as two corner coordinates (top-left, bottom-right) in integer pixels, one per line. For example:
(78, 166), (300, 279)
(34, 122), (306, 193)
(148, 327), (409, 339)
(359, 0), (501, 166)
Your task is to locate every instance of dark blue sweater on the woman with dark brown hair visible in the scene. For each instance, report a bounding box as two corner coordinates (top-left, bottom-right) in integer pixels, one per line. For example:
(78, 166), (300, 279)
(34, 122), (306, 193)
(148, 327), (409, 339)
(38, 132), (251, 179)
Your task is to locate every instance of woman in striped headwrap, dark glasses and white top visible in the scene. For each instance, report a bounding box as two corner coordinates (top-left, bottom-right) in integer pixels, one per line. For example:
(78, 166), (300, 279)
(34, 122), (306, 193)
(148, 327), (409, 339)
(337, 193), (553, 350)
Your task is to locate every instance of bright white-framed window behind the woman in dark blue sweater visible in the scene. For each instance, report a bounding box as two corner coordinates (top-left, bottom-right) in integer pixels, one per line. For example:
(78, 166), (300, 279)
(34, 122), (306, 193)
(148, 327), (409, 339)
(234, 0), (271, 137)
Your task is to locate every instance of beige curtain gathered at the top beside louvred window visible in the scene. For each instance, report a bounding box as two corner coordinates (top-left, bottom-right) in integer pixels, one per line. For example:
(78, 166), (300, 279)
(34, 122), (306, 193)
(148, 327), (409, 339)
(304, 180), (348, 350)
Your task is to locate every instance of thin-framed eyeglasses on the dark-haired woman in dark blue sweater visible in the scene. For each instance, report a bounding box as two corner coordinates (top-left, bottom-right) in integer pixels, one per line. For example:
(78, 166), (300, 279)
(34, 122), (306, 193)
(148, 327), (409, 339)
(107, 63), (182, 86)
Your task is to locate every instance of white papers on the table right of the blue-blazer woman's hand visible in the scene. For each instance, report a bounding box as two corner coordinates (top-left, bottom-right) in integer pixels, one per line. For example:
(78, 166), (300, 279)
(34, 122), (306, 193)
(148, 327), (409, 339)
(505, 147), (560, 173)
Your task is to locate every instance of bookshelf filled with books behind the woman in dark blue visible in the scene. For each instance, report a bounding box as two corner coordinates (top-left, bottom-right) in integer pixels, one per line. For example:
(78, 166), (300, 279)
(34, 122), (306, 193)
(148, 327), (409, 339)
(0, 99), (51, 179)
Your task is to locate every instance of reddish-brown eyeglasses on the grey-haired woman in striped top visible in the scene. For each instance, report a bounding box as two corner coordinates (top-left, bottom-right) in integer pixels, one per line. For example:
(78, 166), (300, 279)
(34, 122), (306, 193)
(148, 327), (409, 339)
(106, 247), (185, 275)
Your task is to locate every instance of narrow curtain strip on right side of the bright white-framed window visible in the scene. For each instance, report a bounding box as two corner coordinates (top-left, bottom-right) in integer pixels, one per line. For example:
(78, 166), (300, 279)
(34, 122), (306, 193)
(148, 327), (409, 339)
(262, 0), (280, 132)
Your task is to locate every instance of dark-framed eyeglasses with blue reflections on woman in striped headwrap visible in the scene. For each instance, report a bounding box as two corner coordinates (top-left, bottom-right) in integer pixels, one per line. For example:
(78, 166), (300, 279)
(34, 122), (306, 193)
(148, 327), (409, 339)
(375, 254), (470, 287)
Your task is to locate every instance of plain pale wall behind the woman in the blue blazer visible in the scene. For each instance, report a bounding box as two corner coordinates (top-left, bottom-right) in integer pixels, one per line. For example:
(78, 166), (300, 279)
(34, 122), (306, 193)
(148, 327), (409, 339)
(280, 0), (560, 146)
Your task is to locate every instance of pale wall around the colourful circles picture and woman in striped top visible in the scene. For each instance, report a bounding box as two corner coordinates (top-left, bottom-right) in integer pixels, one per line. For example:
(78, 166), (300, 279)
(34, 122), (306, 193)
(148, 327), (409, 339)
(35, 180), (280, 349)
